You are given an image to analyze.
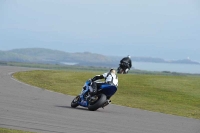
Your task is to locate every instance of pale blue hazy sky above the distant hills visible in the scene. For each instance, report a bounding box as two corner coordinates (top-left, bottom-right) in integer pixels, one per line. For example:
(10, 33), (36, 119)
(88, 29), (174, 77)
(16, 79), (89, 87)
(0, 0), (200, 62)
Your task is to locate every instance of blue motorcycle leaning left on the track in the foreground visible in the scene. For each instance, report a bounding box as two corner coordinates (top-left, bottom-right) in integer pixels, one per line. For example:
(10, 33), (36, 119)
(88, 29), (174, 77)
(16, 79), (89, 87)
(71, 80), (117, 111)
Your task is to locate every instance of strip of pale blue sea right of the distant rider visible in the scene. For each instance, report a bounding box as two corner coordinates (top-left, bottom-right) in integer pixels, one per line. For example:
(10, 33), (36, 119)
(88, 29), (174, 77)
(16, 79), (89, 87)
(132, 62), (200, 74)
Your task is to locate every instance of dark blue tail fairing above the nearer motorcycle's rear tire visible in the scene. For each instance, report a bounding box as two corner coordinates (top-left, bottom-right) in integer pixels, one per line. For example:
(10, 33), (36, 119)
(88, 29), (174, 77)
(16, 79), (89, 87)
(100, 84), (117, 96)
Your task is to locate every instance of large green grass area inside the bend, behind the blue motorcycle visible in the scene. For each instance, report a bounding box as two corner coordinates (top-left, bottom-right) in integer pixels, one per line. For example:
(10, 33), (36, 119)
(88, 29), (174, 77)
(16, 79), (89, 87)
(14, 70), (200, 119)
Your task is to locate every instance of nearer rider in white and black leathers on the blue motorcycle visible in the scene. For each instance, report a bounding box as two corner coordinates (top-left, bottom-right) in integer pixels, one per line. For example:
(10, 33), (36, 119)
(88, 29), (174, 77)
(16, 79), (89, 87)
(89, 68), (118, 101)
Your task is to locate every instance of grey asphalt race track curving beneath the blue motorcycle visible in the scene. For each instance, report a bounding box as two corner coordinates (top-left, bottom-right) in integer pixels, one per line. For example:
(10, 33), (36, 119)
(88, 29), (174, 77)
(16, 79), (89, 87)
(0, 66), (200, 133)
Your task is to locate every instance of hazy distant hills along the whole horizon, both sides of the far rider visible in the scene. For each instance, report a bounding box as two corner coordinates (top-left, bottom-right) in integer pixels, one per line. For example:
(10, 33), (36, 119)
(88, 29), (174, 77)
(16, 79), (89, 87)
(0, 48), (200, 67)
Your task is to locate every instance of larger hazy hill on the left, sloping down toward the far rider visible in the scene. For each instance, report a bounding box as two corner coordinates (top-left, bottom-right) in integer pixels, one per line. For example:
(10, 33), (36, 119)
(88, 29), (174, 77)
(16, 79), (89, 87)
(0, 48), (114, 65)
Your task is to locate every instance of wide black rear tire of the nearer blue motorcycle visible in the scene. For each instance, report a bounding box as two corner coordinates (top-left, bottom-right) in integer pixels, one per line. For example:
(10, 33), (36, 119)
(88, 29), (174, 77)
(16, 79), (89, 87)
(88, 94), (107, 111)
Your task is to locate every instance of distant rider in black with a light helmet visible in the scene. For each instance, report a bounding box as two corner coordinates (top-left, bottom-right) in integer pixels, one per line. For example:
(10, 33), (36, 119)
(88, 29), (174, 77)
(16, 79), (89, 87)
(120, 55), (132, 73)
